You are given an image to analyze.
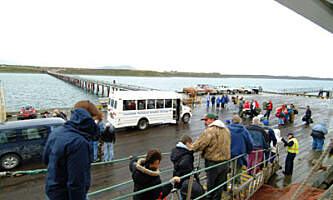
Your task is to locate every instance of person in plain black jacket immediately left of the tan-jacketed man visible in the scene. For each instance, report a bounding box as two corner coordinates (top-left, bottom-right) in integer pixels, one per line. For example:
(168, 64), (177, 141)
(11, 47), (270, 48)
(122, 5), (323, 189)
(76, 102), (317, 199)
(170, 135), (194, 189)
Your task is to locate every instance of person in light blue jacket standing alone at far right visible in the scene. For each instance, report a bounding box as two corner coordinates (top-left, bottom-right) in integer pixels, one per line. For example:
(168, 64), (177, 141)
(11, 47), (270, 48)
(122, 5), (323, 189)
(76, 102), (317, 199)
(311, 122), (327, 152)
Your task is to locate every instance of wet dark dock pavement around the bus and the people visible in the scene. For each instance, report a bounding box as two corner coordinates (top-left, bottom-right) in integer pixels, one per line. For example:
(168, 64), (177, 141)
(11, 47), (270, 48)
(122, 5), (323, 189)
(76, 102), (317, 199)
(0, 94), (333, 200)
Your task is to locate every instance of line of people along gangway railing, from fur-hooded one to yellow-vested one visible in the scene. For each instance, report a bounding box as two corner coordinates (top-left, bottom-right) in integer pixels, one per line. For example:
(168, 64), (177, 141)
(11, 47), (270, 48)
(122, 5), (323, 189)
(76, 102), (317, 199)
(130, 113), (299, 200)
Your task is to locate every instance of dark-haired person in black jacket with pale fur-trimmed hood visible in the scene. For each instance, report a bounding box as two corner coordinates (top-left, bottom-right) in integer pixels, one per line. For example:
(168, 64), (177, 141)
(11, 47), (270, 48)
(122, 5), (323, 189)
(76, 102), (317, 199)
(129, 149), (180, 200)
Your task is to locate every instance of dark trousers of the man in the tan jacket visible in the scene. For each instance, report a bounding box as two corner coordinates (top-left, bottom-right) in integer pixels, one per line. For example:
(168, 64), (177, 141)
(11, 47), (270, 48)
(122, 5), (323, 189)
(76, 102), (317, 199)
(205, 160), (228, 200)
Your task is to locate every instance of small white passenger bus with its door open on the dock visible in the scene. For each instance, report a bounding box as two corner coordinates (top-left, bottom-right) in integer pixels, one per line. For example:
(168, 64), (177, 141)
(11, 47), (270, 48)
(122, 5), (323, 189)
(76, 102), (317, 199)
(107, 91), (192, 130)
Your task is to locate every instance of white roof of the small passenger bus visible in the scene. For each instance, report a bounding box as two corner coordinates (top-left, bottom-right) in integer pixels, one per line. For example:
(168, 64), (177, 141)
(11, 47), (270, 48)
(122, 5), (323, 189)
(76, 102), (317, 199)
(110, 91), (182, 100)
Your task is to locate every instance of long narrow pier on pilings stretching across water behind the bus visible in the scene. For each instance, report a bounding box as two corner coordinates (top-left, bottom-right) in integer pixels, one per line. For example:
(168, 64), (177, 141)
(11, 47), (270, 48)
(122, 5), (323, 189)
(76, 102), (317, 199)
(47, 71), (158, 97)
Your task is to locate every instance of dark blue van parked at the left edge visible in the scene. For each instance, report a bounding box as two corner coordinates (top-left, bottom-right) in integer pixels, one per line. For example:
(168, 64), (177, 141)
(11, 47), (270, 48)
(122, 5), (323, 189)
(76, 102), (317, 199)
(0, 118), (65, 170)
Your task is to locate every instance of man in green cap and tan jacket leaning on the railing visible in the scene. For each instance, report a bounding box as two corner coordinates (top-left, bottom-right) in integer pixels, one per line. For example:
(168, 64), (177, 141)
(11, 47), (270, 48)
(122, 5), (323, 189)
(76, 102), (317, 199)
(191, 113), (231, 200)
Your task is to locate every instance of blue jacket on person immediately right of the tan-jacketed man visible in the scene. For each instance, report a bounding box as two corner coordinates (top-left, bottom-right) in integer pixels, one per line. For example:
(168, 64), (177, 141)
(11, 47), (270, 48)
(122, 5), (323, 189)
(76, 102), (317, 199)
(228, 124), (253, 166)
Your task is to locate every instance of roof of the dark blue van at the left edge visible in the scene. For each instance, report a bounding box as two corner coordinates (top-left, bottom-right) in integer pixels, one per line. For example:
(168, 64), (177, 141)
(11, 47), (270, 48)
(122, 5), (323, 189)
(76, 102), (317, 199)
(0, 117), (65, 130)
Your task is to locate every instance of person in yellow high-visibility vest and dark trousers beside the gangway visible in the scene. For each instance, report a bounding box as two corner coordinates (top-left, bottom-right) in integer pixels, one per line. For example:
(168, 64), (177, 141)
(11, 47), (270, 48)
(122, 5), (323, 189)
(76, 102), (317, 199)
(282, 133), (299, 176)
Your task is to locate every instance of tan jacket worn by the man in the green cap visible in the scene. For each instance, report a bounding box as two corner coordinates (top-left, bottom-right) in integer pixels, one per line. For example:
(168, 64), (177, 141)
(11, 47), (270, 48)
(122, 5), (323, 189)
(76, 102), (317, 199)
(191, 120), (231, 162)
